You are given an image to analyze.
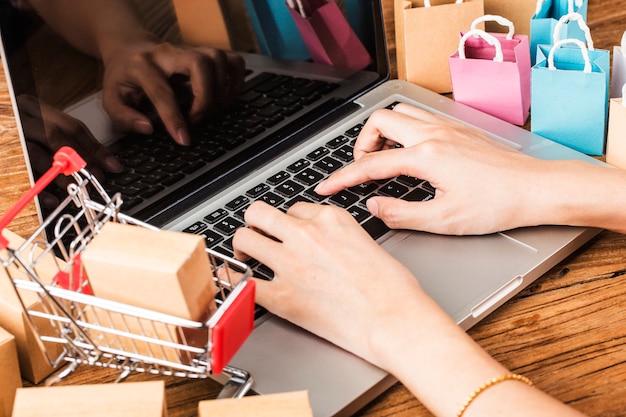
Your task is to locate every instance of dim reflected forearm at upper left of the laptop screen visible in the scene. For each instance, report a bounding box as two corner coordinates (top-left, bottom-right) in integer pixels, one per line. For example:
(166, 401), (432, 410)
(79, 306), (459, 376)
(29, 0), (154, 59)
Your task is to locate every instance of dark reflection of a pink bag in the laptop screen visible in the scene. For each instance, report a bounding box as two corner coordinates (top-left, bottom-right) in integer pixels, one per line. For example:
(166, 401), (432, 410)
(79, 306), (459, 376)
(287, 0), (372, 70)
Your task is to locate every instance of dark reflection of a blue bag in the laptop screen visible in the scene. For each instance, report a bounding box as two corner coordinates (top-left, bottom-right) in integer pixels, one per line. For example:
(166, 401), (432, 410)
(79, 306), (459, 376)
(245, 0), (310, 60)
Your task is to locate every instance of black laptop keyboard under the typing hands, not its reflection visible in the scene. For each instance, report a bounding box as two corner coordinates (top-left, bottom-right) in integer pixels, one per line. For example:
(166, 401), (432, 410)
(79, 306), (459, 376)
(183, 106), (435, 314)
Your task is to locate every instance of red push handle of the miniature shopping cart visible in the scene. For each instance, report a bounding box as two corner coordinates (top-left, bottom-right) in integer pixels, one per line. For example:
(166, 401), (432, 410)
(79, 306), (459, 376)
(0, 146), (87, 249)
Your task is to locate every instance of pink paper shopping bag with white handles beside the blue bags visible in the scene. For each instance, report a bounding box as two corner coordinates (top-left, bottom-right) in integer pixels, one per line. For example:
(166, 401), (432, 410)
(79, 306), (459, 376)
(449, 15), (530, 125)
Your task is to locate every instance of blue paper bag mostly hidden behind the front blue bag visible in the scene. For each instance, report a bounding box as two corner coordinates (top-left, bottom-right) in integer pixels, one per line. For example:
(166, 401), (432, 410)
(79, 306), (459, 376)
(530, 0), (587, 65)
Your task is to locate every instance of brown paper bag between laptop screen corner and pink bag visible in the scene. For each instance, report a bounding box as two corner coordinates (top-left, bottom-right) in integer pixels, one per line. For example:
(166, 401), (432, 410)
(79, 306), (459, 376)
(394, 0), (484, 93)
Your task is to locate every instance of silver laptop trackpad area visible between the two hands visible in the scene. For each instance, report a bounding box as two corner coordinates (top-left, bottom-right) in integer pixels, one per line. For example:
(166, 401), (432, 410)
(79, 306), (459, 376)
(383, 233), (537, 323)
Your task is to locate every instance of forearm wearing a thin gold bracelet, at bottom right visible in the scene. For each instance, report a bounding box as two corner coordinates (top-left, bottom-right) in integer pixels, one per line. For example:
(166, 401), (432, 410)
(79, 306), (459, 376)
(374, 295), (580, 417)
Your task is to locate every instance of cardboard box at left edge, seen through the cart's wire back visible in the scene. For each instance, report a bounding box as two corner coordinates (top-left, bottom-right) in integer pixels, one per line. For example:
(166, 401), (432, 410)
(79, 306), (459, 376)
(0, 229), (62, 384)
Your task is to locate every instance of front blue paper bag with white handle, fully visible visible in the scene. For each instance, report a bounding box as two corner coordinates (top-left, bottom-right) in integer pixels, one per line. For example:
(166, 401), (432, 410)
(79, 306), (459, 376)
(530, 39), (610, 155)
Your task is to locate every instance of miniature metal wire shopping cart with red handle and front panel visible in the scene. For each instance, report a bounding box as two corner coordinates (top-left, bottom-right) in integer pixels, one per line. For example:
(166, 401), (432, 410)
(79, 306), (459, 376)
(0, 147), (255, 397)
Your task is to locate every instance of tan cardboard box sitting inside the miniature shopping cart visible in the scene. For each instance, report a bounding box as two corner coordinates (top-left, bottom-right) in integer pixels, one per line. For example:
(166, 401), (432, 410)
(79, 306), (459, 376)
(81, 223), (217, 321)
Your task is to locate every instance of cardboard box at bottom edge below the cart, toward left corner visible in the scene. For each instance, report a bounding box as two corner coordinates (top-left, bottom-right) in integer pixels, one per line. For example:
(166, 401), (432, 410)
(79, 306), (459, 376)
(13, 381), (167, 417)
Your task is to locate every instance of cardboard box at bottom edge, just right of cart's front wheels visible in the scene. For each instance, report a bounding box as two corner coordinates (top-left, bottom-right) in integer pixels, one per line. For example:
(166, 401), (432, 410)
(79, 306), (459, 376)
(198, 391), (313, 417)
